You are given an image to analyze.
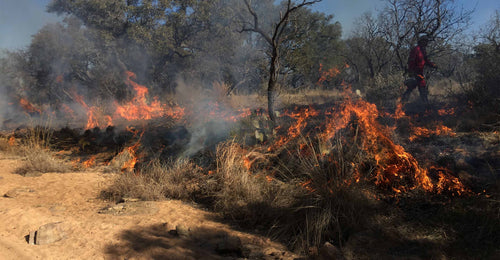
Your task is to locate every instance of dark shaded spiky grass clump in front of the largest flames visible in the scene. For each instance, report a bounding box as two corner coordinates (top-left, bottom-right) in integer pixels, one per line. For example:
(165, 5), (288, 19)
(276, 136), (375, 249)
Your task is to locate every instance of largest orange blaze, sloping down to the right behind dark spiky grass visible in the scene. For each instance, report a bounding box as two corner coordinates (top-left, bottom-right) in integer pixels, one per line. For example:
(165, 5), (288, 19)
(288, 90), (465, 194)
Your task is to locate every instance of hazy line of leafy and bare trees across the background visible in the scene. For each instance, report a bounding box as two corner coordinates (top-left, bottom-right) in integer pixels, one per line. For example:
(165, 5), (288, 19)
(0, 0), (500, 113)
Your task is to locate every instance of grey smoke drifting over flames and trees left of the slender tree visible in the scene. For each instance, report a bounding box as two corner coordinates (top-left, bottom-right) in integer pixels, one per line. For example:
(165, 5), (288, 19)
(0, 0), (270, 157)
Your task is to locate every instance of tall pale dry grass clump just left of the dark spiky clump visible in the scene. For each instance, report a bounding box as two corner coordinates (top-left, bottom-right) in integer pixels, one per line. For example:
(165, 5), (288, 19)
(212, 142), (298, 227)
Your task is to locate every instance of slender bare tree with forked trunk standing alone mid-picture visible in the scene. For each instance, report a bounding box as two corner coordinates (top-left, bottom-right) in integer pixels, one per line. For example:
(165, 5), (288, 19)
(241, 0), (321, 123)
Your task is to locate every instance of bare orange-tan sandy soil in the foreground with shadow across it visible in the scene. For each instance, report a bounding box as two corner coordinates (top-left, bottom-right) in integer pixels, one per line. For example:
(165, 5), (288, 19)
(0, 153), (296, 259)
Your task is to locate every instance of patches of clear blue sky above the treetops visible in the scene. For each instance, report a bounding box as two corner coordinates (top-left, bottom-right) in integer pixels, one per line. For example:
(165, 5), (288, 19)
(0, 0), (500, 50)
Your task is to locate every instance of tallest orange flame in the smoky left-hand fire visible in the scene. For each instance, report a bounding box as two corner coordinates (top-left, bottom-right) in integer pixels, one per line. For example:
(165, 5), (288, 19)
(115, 71), (184, 121)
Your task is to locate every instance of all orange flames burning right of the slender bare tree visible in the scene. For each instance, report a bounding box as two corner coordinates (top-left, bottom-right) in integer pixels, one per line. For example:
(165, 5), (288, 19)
(270, 90), (466, 194)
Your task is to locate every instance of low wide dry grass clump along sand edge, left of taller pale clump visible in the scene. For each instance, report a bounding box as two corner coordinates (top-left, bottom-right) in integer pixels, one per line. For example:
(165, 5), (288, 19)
(102, 157), (205, 201)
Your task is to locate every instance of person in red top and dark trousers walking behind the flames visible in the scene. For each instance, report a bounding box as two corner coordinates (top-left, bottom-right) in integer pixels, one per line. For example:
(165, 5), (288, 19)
(401, 35), (437, 104)
